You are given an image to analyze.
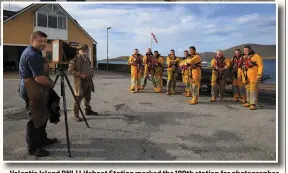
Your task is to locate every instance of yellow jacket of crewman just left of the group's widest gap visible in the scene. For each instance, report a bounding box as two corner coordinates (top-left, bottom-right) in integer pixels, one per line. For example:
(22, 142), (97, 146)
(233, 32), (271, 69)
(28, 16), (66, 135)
(185, 53), (202, 81)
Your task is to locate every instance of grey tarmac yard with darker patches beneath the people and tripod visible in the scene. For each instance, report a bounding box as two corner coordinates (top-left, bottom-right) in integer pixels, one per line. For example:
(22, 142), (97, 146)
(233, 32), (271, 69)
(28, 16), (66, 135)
(3, 72), (276, 161)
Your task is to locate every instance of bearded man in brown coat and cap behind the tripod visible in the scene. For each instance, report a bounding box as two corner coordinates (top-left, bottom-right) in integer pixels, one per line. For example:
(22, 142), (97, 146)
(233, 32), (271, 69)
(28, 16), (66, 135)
(68, 44), (98, 122)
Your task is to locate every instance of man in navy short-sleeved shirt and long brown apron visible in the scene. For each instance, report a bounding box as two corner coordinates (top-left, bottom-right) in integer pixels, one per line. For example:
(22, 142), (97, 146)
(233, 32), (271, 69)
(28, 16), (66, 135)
(19, 31), (57, 157)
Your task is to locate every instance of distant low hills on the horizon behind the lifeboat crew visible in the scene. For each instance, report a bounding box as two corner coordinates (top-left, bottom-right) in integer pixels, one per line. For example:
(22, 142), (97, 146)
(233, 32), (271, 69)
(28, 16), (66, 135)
(101, 43), (276, 61)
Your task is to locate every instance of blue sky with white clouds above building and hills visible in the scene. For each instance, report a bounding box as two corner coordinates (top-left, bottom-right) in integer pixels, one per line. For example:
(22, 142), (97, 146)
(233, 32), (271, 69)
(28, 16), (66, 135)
(3, 3), (276, 60)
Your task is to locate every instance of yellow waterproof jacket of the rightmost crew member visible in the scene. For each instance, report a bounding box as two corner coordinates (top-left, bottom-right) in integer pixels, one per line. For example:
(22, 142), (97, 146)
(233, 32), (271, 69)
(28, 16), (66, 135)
(238, 53), (263, 83)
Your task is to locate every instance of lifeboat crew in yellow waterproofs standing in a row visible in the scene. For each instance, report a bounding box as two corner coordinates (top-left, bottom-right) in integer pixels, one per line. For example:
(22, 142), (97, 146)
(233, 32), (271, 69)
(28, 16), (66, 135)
(128, 45), (263, 110)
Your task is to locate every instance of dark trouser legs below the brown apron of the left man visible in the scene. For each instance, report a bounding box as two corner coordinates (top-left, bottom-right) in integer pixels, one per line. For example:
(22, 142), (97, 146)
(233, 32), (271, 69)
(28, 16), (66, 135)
(26, 120), (47, 150)
